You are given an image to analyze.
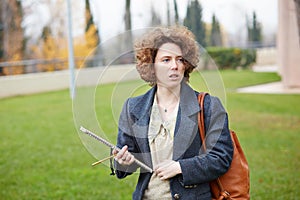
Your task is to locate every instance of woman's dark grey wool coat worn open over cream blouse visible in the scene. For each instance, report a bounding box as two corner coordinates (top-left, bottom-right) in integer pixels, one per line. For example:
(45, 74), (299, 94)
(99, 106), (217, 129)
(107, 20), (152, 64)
(115, 82), (233, 200)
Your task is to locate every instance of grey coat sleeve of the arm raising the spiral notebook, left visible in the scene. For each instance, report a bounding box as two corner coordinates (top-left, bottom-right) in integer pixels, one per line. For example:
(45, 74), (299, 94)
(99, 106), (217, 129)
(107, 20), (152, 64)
(114, 99), (138, 178)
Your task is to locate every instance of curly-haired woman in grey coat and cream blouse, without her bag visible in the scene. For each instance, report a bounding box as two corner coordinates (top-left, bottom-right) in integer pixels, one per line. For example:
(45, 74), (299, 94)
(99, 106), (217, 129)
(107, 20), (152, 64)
(113, 26), (233, 200)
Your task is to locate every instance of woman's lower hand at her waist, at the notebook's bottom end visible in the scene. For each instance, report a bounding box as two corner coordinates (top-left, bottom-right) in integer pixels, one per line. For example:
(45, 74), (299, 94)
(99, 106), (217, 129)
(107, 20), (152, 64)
(154, 160), (182, 180)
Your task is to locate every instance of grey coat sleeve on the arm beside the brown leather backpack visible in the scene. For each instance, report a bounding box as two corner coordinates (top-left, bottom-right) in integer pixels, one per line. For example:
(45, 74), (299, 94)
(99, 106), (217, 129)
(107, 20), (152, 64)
(179, 95), (233, 185)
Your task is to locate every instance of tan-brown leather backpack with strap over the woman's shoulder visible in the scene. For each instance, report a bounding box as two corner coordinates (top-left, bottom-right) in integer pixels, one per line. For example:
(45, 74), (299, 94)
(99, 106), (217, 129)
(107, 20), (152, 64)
(198, 93), (250, 200)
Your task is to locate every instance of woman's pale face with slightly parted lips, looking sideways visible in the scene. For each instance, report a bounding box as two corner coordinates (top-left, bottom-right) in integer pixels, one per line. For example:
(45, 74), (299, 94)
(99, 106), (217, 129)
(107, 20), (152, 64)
(154, 43), (185, 88)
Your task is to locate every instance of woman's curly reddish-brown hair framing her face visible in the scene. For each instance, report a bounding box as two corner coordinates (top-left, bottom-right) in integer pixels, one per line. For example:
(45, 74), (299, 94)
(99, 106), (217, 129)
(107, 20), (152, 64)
(134, 26), (200, 86)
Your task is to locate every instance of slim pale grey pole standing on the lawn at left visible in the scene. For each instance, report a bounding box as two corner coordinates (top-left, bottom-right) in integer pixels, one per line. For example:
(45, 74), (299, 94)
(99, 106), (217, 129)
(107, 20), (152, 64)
(67, 0), (75, 99)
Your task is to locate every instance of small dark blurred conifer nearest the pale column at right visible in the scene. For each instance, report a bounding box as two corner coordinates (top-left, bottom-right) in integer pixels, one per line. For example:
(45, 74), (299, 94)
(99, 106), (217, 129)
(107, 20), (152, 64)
(247, 12), (262, 46)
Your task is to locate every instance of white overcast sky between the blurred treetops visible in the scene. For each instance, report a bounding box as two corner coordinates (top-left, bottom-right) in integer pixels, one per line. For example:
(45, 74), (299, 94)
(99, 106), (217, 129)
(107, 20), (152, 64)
(92, 0), (278, 41)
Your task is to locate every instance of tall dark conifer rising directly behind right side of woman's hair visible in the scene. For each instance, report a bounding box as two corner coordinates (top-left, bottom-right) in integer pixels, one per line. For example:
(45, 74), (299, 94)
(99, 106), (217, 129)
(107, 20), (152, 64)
(183, 0), (206, 46)
